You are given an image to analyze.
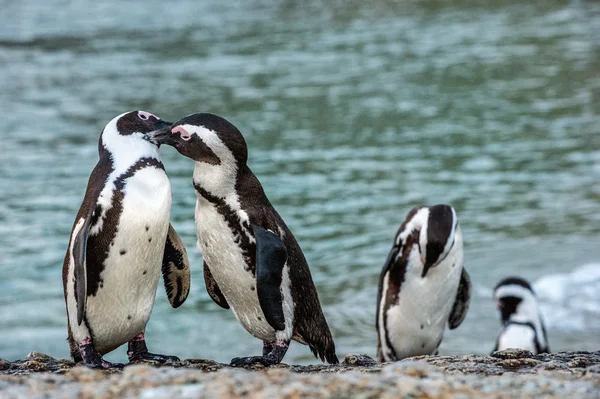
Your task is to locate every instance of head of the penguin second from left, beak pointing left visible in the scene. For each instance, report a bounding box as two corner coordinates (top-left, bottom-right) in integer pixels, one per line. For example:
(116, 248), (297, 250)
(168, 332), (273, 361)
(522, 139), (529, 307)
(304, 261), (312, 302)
(154, 113), (248, 168)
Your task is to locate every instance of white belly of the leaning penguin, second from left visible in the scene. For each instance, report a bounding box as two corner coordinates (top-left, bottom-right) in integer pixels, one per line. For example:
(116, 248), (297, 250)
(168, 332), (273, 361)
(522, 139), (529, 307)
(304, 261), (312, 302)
(196, 196), (276, 341)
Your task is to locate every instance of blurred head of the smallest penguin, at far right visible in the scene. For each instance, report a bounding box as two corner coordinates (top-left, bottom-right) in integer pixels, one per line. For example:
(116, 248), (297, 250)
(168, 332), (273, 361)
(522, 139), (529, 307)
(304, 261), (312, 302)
(494, 277), (539, 324)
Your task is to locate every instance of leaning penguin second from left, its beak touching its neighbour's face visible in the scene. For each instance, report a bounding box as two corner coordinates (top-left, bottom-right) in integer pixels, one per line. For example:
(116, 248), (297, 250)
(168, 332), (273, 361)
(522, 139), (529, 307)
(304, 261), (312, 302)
(157, 114), (338, 366)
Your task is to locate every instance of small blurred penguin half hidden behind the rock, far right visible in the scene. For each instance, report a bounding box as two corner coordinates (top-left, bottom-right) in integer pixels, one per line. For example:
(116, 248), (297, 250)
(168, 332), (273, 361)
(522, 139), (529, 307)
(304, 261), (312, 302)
(492, 277), (550, 354)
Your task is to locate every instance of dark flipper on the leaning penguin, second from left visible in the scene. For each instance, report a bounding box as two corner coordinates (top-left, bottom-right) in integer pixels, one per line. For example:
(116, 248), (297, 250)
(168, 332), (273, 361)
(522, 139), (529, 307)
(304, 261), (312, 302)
(252, 224), (287, 331)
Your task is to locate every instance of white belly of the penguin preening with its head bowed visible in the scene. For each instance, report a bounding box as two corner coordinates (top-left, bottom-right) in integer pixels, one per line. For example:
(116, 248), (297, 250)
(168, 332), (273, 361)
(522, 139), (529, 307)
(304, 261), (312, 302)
(387, 247), (463, 360)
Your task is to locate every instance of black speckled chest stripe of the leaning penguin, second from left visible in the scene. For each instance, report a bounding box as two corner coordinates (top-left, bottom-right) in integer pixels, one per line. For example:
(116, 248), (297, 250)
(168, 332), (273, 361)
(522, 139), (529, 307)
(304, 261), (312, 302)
(194, 183), (256, 276)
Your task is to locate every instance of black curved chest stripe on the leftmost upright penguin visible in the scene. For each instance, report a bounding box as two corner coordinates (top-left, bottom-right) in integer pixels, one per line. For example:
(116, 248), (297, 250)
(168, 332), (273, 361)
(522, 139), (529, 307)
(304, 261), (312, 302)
(86, 158), (165, 296)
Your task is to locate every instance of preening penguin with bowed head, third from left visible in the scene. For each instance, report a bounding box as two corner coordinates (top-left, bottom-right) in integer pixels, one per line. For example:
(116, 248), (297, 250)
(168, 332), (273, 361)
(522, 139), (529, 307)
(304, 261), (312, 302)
(376, 205), (471, 362)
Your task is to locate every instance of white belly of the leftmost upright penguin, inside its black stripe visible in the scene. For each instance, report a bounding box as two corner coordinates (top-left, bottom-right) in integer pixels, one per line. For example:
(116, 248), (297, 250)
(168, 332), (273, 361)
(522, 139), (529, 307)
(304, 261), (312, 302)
(72, 168), (171, 354)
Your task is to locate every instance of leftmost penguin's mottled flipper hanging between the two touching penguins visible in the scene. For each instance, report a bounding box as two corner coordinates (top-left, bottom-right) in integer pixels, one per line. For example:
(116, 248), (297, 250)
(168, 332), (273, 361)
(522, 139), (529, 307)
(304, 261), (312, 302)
(161, 224), (190, 308)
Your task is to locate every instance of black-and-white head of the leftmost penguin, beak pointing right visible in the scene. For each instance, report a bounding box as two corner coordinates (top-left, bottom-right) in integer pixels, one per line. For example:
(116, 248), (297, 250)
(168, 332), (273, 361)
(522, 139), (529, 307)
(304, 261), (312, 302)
(98, 111), (171, 157)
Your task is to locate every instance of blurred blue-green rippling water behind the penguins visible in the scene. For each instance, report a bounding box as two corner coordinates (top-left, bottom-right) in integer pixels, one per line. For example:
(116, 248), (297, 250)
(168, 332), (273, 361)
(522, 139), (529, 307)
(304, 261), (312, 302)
(0, 0), (600, 363)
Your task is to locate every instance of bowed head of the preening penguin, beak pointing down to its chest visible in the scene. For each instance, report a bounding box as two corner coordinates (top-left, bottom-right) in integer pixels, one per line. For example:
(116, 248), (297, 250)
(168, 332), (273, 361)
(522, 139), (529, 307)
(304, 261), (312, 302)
(395, 205), (462, 277)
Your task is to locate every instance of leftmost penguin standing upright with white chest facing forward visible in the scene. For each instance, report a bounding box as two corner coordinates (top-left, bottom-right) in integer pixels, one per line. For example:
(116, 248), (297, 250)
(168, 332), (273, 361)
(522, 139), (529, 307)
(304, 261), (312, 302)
(63, 111), (190, 368)
